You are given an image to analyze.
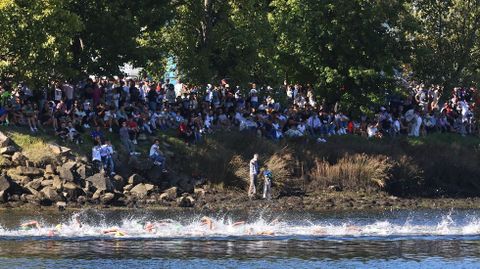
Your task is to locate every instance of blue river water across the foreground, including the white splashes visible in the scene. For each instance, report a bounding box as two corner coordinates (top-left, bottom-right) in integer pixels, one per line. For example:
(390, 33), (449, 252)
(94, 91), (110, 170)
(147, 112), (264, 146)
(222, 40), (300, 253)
(0, 210), (480, 269)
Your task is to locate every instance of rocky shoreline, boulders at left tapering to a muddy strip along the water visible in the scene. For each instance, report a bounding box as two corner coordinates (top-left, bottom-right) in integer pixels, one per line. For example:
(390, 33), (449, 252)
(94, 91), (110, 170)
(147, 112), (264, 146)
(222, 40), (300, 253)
(0, 132), (480, 211)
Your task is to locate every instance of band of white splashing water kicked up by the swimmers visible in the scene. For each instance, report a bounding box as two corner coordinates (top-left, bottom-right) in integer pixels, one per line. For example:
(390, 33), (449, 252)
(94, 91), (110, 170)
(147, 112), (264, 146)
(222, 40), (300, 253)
(0, 209), (480, 239)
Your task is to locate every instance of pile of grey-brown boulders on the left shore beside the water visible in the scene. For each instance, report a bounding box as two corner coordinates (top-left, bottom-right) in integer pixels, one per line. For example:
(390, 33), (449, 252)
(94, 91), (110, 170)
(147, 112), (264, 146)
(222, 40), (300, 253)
(0, 132), (204, 208)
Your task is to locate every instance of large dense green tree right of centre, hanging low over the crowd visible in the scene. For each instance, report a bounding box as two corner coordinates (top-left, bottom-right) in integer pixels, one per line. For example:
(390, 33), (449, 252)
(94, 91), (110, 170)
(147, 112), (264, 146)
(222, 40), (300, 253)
(270, 0), (409, 111)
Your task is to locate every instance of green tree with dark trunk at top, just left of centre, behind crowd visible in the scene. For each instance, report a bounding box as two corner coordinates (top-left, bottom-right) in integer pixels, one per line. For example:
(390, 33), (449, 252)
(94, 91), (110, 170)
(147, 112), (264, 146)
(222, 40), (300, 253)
(159, 0), (277, 83)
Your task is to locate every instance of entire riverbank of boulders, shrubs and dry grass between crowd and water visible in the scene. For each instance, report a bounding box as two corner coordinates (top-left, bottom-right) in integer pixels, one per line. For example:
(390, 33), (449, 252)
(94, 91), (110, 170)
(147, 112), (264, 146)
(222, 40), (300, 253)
(0, 129), (480, 210)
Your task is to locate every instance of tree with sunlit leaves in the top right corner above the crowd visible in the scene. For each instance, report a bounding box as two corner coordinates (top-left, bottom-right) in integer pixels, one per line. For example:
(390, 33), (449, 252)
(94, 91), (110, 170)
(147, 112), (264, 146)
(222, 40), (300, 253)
(409, 0), (480, 88)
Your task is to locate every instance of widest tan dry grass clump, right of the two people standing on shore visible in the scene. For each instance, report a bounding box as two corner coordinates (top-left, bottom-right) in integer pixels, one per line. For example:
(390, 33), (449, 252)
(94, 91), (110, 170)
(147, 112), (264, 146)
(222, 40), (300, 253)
(311, 154), (393, 190)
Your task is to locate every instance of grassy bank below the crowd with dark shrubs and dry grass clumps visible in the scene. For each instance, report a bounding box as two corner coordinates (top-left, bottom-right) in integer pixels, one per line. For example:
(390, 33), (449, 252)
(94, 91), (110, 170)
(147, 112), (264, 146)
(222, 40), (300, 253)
(0, 124), (480, 198)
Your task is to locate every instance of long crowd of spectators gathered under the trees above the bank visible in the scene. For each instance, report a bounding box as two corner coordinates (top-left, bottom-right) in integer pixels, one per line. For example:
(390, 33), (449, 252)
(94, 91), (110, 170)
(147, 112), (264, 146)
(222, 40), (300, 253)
(0, 78), (477, 163)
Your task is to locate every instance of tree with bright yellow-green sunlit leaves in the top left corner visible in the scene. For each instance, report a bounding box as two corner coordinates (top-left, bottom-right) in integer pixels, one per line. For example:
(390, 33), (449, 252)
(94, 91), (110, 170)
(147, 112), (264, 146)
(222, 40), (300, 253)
(0, 0), (82, 84)
